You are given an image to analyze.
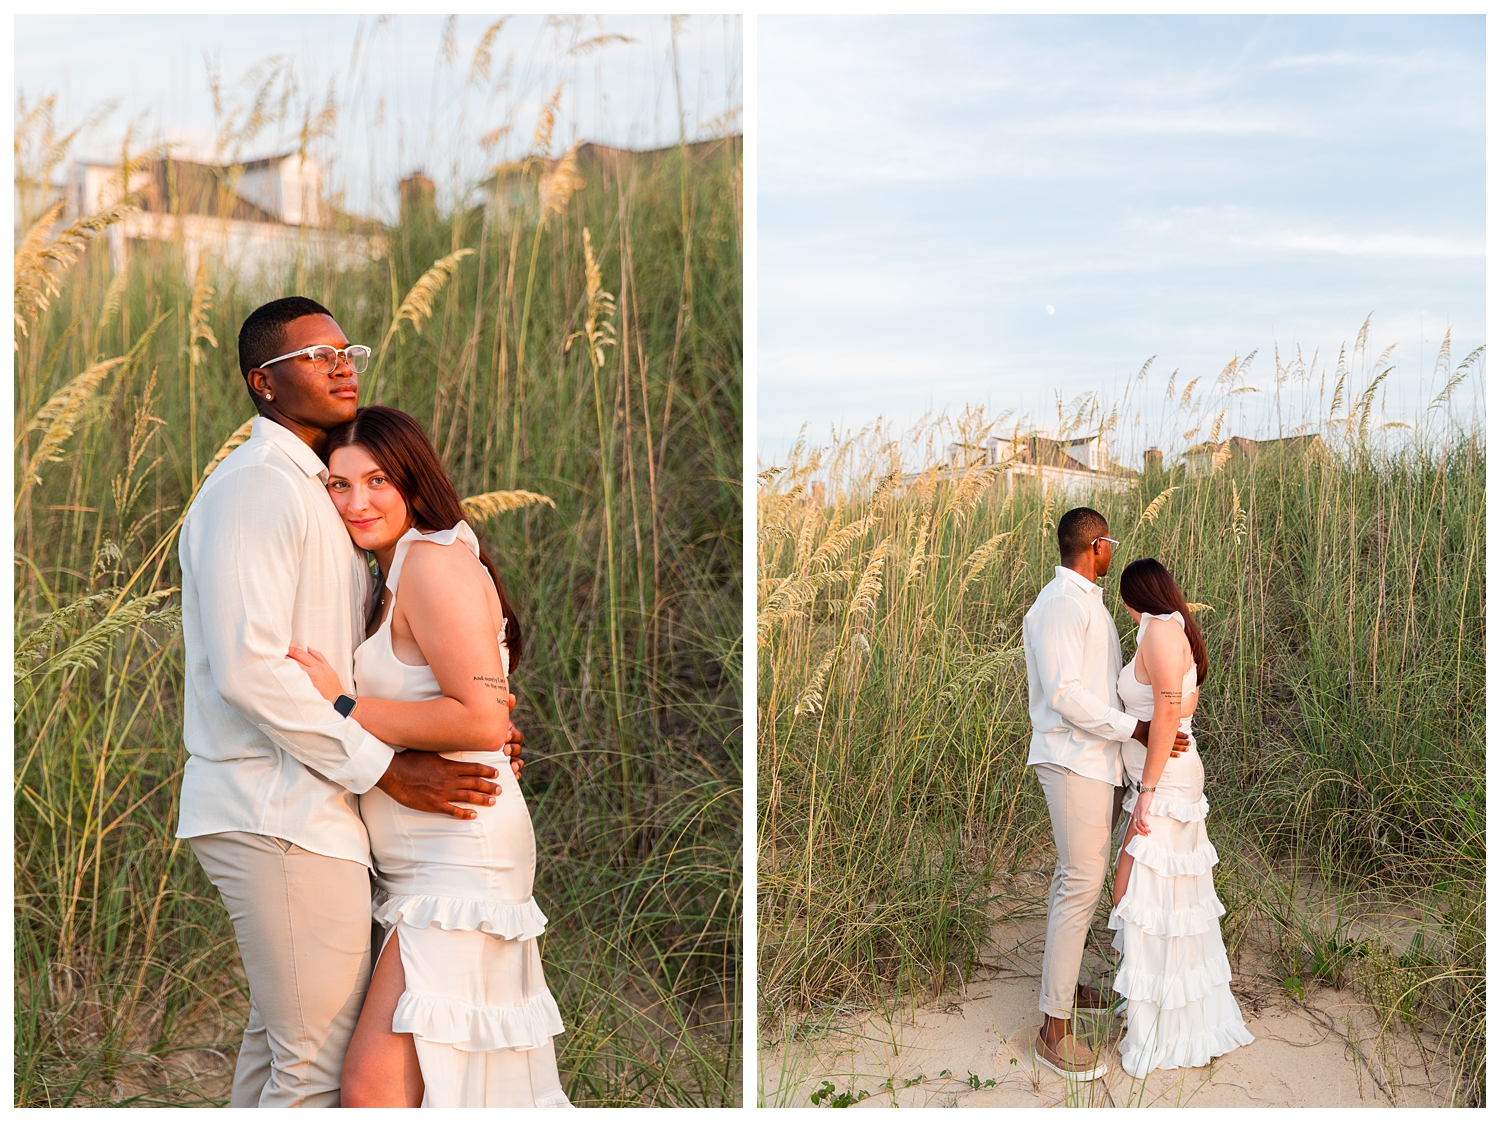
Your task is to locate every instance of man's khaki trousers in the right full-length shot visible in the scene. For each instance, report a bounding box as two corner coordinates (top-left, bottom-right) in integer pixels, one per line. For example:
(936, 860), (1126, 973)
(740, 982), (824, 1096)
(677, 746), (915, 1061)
(1035, 764), (1125, 1020)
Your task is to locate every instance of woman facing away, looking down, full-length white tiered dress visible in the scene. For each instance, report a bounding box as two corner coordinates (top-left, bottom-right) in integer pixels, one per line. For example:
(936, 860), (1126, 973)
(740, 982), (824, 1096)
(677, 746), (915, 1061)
(1110, 558), (1254, 1079)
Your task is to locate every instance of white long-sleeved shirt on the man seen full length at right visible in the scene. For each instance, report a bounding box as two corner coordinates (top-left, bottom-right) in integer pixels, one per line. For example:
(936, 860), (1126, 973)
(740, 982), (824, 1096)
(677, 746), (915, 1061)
(1022, 566), (1136, 786)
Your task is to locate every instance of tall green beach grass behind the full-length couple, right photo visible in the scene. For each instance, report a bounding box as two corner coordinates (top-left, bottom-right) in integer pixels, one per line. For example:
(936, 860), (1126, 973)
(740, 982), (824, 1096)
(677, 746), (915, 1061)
(758, 351), (1485, 1106)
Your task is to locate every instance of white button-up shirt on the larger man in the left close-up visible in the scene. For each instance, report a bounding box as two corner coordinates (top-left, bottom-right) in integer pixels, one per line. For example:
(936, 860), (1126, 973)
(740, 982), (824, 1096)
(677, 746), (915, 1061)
(177, 417), (393, 866)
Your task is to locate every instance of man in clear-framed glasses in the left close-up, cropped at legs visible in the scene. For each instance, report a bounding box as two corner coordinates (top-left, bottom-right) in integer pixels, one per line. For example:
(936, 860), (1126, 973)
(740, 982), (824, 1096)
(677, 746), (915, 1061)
(177, 297), (519, 1107)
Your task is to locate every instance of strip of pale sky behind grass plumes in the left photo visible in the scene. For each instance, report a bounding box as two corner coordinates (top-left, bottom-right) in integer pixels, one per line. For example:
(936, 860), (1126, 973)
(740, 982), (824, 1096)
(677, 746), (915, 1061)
(15, 15), (743, 218)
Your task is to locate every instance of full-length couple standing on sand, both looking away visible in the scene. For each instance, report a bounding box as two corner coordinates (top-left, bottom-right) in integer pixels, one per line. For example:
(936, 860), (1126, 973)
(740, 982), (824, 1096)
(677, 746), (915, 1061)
(1023, 507), (1254, 1080)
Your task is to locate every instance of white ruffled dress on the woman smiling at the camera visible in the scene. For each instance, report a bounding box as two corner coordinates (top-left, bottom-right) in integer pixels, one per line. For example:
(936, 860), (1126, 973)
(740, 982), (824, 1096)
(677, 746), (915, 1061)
(354, 522), (572, 1107)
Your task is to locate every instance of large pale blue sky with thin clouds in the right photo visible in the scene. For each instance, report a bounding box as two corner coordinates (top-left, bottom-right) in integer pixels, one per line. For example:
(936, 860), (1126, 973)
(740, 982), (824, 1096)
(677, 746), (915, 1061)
(758, 17), (1485, 459)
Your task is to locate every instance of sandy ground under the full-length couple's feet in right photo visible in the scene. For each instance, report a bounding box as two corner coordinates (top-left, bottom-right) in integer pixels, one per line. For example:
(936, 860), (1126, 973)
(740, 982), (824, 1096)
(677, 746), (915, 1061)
(759, 920), (1448, 1107)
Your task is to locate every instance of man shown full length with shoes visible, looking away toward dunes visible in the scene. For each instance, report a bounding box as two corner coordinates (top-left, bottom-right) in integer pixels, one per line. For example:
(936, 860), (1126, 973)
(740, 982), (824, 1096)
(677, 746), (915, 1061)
(1022, 507), (1188, 1080)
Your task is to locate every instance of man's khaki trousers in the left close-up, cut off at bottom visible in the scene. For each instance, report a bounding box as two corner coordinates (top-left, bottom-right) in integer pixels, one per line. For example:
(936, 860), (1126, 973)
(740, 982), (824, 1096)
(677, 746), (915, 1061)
(191, 833), (371, 1107)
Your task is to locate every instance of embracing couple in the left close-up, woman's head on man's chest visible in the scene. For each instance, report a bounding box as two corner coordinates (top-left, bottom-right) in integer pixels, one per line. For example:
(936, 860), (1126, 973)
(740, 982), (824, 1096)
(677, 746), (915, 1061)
(177, 297), (569, 1107)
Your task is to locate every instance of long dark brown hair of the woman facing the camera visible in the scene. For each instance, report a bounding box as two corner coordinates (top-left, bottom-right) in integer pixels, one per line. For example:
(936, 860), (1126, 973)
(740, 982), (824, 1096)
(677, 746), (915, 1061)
(323, 405), (525, 671)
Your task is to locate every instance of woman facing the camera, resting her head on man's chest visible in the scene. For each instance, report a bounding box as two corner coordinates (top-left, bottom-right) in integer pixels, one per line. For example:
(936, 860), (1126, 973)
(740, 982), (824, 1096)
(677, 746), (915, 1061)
(290, 405), (570, 1107)
